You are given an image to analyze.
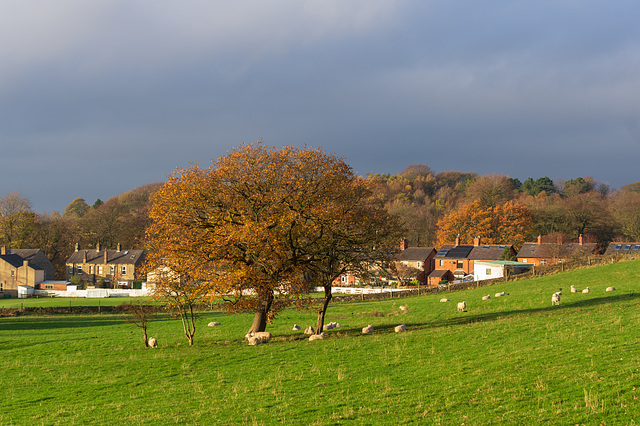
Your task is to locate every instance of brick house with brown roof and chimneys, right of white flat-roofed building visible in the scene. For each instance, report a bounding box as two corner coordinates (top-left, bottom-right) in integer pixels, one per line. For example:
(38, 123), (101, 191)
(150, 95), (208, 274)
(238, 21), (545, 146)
(516, 235), (598, 266)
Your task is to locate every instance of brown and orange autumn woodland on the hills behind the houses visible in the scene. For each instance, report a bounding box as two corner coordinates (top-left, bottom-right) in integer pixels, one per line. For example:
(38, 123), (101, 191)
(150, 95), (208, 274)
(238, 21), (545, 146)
(0, 164), (640, 279)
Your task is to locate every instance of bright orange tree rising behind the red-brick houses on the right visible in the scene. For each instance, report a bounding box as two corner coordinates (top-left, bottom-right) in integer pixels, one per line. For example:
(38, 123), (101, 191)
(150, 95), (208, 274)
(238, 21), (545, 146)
(438, 200), (533, 246)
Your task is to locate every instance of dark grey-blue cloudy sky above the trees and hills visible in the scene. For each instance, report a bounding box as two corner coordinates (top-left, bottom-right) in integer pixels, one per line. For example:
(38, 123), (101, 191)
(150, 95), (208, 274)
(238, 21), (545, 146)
(0, 0), (640, 213)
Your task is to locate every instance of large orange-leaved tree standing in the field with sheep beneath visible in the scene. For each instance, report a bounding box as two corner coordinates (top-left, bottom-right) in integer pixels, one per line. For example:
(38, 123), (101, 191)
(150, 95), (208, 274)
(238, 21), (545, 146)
(147, 142), (402, 333)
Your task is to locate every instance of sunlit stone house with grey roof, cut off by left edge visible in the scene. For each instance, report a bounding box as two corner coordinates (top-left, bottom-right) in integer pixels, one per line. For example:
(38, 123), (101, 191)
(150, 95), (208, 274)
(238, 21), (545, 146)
(0, 246), (54, 297)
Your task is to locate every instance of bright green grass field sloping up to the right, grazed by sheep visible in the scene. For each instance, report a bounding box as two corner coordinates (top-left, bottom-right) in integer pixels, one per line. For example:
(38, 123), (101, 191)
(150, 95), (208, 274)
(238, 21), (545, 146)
(0, 261), (640, 425)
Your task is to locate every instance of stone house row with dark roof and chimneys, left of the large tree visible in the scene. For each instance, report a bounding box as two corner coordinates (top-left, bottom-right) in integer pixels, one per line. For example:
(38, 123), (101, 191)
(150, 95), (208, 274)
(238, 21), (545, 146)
(66, 244), (144, 288)
